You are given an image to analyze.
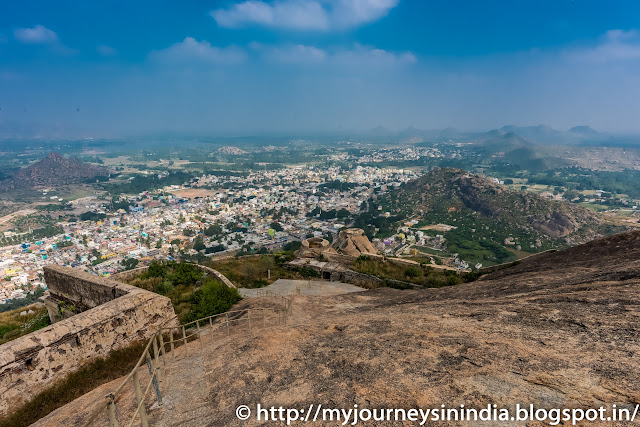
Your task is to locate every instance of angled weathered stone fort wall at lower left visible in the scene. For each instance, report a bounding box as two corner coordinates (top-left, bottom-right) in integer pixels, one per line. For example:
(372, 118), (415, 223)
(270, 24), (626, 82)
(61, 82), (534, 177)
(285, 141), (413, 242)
(0, 266), (178, 415)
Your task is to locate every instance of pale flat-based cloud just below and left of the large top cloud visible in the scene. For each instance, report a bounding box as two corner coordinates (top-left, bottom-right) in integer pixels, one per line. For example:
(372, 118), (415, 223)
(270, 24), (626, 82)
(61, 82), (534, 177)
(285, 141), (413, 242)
(150, 37), (246, 64)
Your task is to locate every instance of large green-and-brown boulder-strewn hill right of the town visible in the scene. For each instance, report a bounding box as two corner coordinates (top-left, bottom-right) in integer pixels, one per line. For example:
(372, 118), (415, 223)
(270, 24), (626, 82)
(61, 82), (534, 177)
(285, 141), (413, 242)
(379, 168), (607, 250)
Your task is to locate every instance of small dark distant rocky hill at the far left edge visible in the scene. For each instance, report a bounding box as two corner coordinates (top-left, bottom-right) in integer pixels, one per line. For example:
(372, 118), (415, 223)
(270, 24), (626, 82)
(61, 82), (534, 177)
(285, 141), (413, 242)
(0, 153), (109, 189)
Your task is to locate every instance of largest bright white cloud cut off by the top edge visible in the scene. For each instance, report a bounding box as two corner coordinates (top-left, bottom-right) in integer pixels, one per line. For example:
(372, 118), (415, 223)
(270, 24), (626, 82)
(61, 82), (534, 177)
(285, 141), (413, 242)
(211, 0), (398, 31)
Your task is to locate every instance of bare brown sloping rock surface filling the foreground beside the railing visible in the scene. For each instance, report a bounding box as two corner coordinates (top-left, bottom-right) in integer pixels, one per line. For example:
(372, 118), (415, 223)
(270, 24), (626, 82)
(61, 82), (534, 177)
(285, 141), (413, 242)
(37, 232), (640, 426)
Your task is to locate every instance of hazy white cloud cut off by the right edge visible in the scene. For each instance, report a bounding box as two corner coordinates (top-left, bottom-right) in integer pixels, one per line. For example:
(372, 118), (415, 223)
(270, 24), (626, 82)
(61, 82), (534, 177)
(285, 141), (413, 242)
(569, 30), (640, 63)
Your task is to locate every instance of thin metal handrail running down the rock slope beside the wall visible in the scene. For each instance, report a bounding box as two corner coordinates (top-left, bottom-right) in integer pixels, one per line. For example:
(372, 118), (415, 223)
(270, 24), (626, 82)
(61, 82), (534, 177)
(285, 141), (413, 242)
(83, 295), (291, 427)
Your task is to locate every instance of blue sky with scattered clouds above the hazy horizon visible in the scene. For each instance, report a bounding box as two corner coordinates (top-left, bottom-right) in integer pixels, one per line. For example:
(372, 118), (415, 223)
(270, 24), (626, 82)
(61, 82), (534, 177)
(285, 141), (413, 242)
(0, 0), (640, 136)
